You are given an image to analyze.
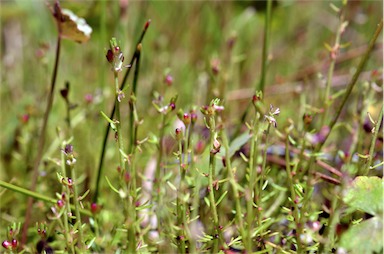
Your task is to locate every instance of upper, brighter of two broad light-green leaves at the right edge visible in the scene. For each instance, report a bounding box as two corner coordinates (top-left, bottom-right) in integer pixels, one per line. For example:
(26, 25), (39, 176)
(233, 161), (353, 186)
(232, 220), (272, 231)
(343, 176), (384, 216)
